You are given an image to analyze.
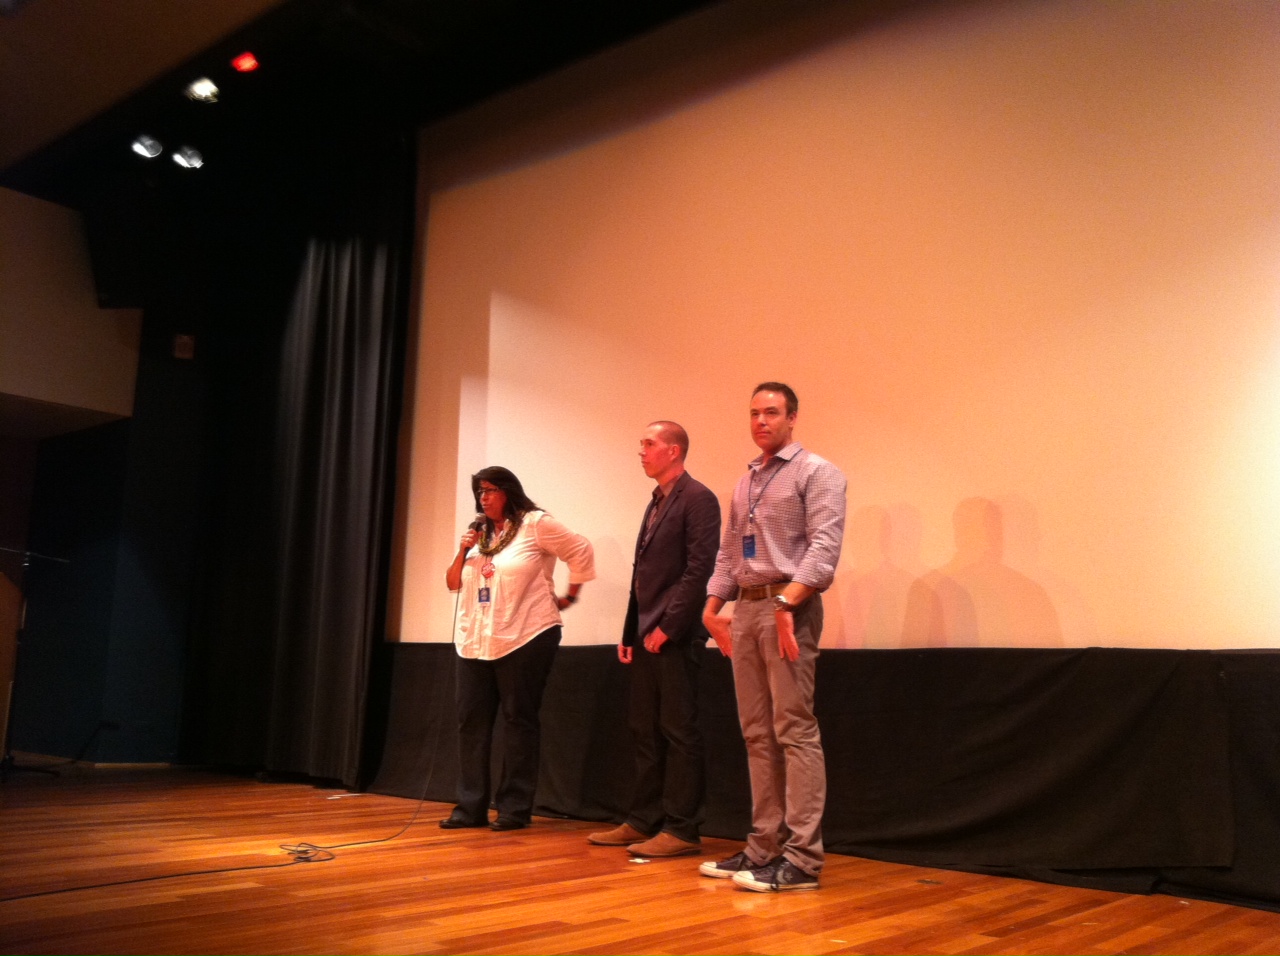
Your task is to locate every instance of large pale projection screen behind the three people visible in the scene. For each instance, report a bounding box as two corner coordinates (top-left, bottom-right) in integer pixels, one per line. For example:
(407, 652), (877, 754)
(390, 0), (1280, 648)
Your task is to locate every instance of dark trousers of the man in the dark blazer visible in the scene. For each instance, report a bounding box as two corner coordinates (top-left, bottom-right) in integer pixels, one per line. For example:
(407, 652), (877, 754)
(627, 640), (707, 842)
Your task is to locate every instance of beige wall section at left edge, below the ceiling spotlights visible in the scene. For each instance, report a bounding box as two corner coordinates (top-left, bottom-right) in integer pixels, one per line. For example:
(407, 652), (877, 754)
(0, 189), (142, 416)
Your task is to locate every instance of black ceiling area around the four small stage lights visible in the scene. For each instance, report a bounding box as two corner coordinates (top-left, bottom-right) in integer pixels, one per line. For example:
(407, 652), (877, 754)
(0, 0), (737, 209)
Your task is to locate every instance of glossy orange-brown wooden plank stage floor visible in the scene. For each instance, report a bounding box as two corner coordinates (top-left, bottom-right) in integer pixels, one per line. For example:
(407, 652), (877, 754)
(0, 767), (1280, 956)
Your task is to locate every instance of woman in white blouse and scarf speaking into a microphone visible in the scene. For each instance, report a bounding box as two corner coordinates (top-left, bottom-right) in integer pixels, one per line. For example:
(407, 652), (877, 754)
(440, 466), (595, 831)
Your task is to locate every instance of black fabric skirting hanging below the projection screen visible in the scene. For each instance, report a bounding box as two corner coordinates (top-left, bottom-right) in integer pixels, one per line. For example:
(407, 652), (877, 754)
(372, 645), (1280, 909)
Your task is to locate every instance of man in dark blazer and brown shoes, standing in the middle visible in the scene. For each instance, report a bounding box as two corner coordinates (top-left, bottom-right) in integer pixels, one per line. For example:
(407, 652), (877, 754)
(588, 421), (721, 857)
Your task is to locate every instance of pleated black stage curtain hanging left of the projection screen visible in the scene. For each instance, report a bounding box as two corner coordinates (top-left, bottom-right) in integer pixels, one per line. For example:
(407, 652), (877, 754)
(266, 202), (408, 785)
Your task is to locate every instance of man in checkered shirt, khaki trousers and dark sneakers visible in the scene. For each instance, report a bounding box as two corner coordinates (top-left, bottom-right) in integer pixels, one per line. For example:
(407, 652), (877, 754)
(699, 381), (847, 892)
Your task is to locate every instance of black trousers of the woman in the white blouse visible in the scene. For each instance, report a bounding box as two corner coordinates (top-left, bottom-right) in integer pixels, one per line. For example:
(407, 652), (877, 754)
(454, 625), (561, 823)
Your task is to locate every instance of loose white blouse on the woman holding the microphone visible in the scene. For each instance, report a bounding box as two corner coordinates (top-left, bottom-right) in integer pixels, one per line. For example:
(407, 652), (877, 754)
(453, 511), (595, 660)
